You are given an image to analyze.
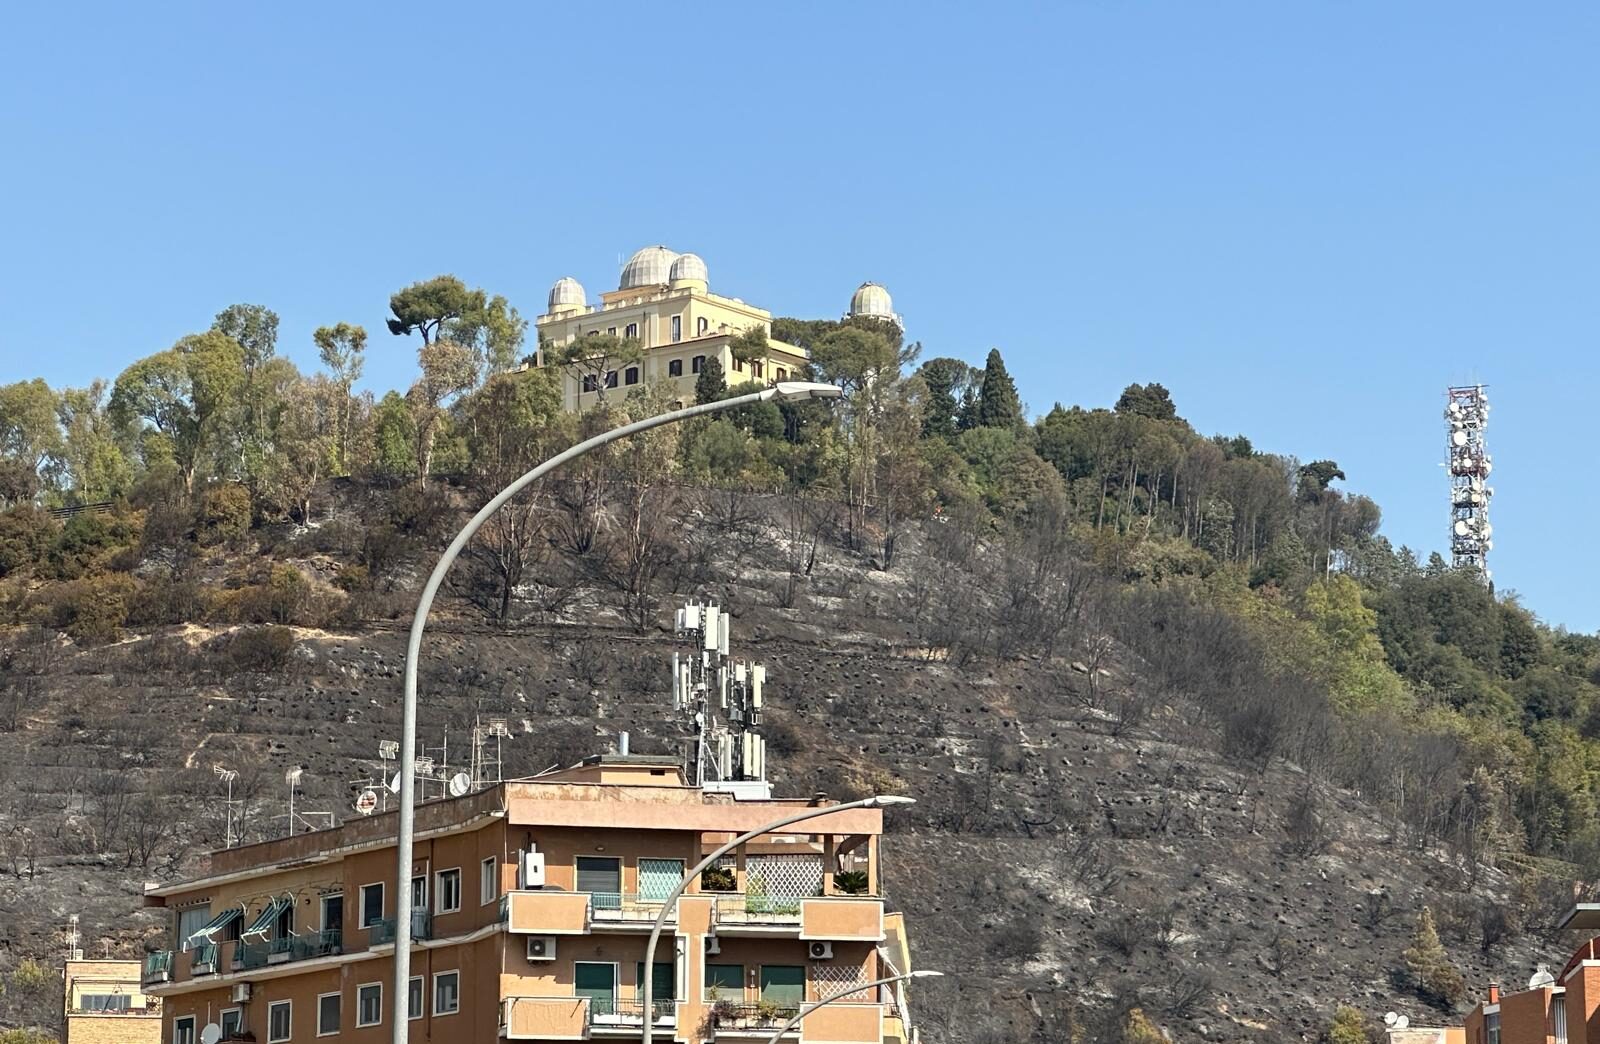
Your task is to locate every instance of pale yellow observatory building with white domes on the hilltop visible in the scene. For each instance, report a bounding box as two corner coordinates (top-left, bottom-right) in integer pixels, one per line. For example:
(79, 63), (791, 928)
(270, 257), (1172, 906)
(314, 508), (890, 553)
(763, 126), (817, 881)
(533, 245), (901, 412)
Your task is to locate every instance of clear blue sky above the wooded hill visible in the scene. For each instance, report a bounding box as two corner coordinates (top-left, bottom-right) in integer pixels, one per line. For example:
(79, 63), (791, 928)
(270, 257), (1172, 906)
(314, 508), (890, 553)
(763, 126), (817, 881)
(0, 0), (1600, 631)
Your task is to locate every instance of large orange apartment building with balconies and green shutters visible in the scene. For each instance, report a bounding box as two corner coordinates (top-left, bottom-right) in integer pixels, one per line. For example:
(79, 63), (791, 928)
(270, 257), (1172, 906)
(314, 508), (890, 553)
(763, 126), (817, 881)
(142, 756), (912, 1044)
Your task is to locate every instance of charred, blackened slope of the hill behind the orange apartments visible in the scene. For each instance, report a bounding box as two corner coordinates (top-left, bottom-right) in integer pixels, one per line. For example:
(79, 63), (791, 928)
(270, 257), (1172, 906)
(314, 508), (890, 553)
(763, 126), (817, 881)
(0, 485), (1570, 1044)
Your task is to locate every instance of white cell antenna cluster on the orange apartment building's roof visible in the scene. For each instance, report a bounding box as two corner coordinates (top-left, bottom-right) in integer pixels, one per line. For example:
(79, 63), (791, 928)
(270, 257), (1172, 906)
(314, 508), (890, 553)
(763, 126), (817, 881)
(672, 602), (768, 796)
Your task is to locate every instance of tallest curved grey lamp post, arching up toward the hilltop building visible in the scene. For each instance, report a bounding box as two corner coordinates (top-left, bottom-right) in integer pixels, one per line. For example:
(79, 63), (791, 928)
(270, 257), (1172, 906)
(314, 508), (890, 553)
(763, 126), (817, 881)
(389, 381), (843, 1044)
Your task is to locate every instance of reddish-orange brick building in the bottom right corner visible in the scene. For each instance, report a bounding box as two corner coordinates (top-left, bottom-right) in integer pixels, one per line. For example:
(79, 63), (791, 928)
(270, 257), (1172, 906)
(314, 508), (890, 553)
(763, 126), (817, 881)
(1466, 903), (1600, 1044)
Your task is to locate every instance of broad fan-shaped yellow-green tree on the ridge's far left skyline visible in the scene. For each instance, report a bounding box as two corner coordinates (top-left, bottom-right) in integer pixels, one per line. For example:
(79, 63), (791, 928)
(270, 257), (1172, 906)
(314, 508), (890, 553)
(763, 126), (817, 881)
(110, 330), (245, 492)
